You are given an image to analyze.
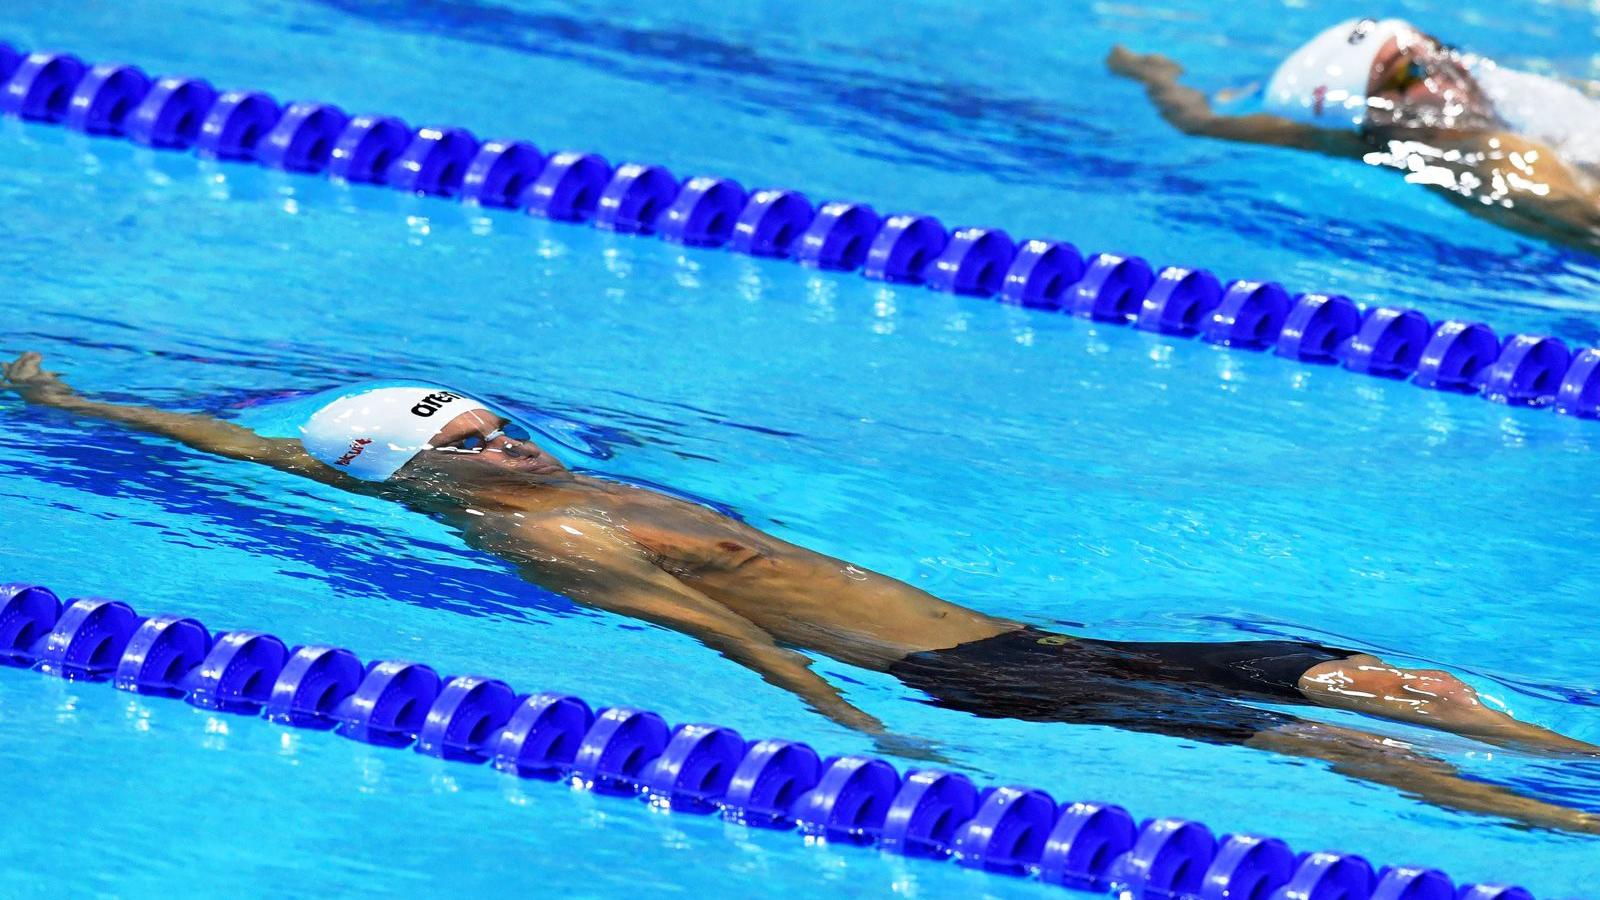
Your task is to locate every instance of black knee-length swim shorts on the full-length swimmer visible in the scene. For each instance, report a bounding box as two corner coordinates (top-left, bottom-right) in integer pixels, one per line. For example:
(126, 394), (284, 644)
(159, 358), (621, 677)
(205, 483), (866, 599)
(888, 628), (1355, 743)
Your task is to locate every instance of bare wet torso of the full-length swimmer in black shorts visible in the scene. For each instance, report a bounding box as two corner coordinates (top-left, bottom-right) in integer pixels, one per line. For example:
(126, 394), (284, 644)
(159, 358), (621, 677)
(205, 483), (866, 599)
(419, 474), (1016, 668)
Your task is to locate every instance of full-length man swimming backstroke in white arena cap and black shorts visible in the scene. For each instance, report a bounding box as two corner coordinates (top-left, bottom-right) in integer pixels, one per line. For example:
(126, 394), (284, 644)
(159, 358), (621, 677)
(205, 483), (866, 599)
(3, 352), (1600, 833)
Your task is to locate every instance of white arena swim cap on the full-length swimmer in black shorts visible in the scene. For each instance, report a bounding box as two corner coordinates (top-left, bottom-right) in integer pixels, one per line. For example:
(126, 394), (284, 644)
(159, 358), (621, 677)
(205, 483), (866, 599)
(299, 384), (494, 482)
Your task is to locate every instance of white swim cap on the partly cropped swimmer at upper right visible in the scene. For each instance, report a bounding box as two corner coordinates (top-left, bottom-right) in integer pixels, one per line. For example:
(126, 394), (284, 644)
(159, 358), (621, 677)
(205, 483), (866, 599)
(1262, 19), (1418, 130)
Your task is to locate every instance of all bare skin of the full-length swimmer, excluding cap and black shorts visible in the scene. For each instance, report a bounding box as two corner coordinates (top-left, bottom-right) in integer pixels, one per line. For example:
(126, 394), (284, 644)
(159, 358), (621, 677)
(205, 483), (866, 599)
(5, 354), (1600, 833)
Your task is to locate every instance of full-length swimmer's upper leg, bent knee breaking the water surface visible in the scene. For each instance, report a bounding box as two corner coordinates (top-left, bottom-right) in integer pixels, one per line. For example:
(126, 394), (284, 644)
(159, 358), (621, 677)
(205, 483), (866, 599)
(1296, 653), (1600, 756)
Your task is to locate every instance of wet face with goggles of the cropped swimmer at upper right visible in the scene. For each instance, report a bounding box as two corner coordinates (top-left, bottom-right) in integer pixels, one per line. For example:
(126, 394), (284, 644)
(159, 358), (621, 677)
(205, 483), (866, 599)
(1366, 32), (1494, 130)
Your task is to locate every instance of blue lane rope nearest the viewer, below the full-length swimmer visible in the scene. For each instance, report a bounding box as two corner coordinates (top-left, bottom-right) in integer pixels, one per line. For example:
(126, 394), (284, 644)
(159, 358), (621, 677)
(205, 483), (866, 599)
(0, 585), (1533, 900)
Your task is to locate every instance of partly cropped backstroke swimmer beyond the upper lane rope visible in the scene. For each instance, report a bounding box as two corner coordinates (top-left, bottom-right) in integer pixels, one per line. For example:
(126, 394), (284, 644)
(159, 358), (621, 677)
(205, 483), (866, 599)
(1106, 19), (1600, 255)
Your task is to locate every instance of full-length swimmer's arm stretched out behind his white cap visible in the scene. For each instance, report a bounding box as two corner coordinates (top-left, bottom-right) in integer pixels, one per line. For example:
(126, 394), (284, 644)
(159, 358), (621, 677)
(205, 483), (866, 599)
(0, 352), (350, 490)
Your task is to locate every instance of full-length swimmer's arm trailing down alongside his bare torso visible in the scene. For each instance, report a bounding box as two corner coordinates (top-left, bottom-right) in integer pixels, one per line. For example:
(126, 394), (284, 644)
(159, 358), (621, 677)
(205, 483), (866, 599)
(502, 514), (889, 736)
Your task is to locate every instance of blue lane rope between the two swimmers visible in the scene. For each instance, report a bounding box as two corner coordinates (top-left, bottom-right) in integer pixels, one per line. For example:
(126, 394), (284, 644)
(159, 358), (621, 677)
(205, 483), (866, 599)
(0, 43), (1600, 418)
